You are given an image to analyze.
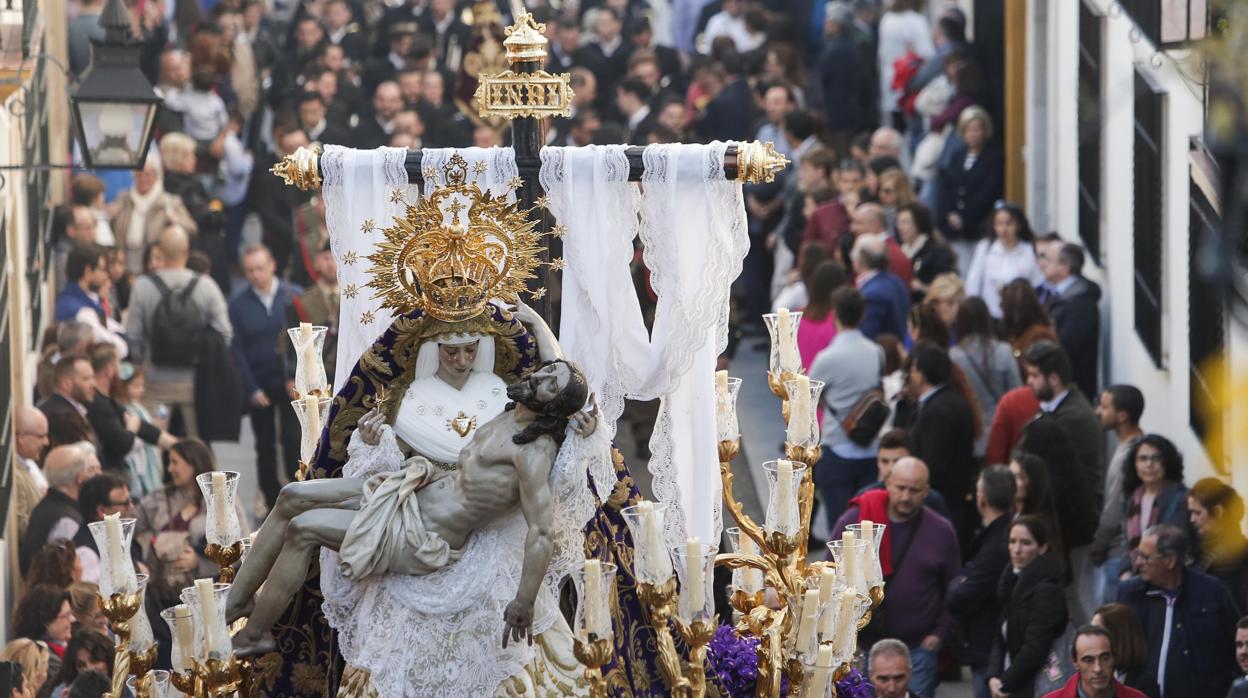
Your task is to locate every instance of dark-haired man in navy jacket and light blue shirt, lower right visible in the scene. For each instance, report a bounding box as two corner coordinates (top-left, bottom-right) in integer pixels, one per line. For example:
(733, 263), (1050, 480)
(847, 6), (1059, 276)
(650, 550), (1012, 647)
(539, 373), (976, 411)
(1118, 524), (1239, 696)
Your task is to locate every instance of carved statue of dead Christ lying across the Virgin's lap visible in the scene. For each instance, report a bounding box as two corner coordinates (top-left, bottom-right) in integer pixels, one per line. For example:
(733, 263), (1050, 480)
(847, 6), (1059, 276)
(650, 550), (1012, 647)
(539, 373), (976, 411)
(227, 360), (589, 656)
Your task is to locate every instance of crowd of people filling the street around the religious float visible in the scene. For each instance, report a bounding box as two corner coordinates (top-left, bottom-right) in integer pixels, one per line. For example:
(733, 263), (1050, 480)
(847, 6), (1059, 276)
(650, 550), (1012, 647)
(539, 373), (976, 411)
(12, 0), (1248, 698)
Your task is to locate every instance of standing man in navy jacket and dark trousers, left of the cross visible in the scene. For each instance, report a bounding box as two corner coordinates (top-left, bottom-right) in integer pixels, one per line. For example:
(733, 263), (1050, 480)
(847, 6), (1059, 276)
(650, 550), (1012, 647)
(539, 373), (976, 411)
(230, 245), (303, 507)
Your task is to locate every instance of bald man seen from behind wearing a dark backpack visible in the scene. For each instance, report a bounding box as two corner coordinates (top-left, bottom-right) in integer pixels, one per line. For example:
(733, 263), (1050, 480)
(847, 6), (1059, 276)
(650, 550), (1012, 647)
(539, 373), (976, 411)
(126, 225), (233, 436)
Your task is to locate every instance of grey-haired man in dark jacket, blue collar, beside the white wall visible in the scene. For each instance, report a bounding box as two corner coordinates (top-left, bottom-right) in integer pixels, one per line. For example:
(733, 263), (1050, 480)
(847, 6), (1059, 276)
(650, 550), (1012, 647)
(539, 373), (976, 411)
(1036, 233), (1101, 404)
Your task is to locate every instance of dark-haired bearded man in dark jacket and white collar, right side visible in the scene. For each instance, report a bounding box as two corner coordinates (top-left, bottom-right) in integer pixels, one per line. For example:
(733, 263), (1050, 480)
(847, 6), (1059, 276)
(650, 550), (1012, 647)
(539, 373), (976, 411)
(1023, 341), (1104, 511)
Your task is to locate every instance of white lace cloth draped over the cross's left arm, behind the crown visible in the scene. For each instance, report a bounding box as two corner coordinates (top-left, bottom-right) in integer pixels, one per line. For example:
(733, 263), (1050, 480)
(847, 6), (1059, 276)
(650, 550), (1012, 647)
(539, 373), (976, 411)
(321, 145), (519, 393)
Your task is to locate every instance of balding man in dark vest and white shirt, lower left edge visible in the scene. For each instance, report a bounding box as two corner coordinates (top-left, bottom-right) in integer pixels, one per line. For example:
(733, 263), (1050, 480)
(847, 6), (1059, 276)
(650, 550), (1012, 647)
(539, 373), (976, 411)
(19, 443), (100, 574)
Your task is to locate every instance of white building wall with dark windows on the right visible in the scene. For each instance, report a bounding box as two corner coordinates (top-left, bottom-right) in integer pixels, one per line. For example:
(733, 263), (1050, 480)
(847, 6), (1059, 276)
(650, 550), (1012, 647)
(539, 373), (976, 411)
(1027, 0), (1223, 483)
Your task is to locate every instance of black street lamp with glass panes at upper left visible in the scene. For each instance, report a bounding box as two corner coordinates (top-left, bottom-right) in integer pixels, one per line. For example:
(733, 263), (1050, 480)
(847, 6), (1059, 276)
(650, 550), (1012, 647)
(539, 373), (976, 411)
(70, 0), (162, 170)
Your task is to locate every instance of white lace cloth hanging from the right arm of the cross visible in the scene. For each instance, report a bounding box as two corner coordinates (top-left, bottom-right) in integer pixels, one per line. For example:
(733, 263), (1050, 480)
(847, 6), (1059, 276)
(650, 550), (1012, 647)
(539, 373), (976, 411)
(540, 142), (749, 554)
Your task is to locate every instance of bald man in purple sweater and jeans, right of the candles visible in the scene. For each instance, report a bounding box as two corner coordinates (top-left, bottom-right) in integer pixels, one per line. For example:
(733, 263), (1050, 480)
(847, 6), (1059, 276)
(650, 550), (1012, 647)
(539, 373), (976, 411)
(832, 457), (962, 698)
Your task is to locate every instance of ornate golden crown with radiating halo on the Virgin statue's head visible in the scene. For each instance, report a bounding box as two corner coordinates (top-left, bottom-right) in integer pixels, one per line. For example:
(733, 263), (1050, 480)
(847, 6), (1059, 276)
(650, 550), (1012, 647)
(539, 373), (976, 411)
(366, 154), (542, 322)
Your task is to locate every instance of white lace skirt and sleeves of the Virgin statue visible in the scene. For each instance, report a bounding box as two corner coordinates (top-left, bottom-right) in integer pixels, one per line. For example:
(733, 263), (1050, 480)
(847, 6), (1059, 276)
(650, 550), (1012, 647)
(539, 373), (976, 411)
(321, 426), (610, 698)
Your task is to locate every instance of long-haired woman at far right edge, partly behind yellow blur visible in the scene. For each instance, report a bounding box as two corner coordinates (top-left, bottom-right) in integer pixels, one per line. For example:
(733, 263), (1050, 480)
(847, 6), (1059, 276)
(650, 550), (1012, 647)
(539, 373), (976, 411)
(1187, 477), (1248, 609)
